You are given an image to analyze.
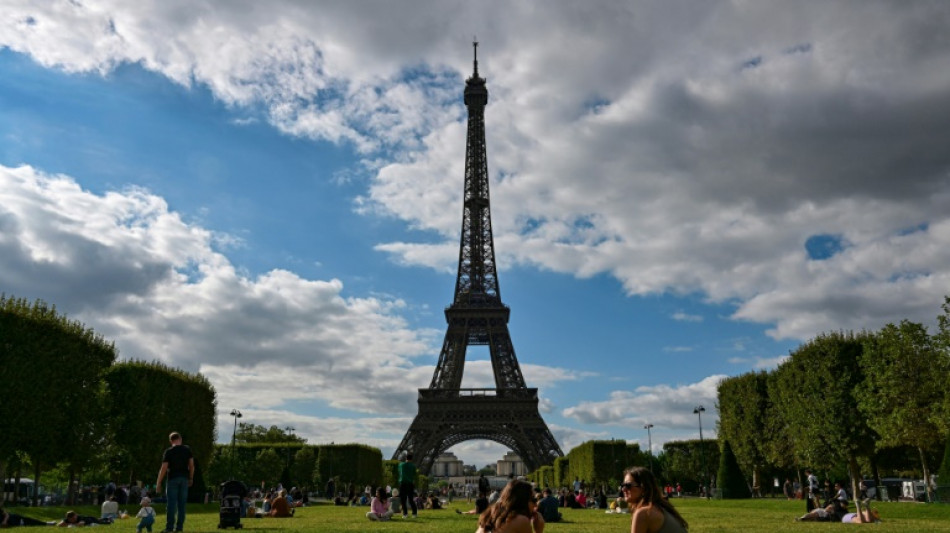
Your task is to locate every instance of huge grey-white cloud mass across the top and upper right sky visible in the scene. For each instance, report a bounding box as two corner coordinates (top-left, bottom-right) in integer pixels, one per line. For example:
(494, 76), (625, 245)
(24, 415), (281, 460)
(7, 1), (950, 339)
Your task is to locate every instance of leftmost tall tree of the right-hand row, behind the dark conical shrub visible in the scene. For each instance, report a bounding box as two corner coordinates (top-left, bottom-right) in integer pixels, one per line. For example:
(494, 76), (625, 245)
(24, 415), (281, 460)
(717, 372), (775, 496)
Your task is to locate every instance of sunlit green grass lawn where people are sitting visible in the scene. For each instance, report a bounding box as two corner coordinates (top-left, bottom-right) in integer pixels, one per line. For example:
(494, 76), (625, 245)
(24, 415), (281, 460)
(11, 498), (950, 533)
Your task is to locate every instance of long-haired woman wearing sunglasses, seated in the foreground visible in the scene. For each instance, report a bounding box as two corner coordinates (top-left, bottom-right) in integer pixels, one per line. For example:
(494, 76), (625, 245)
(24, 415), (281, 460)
(620, 466), (689, 533)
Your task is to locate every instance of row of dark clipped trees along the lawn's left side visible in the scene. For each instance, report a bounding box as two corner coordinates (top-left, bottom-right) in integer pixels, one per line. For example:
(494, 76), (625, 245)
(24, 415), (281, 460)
(0, 295), (215, 502)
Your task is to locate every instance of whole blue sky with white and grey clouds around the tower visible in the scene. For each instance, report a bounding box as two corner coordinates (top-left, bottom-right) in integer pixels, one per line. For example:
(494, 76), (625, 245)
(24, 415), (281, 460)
(0, 0), (950, 466)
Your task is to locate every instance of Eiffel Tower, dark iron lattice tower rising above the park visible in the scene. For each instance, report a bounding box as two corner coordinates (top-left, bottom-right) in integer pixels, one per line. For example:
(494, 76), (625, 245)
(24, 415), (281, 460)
(393, 41), (564, 473)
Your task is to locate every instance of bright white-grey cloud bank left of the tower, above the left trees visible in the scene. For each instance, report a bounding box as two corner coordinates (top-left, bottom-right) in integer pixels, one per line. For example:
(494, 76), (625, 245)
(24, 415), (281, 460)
(0, 166), (435, 415)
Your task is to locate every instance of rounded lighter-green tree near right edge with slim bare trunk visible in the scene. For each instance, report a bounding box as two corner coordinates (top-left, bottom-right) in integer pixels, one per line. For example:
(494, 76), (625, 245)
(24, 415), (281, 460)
(860, 320), (950, 499)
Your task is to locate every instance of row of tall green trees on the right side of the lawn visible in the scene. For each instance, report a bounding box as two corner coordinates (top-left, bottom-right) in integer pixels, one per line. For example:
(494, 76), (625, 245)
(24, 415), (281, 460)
(718, 298), (950, 496)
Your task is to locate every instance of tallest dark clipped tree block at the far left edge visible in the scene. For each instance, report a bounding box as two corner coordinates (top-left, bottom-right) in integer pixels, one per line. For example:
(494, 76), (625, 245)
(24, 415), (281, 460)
(0, 295), (116, 502)
